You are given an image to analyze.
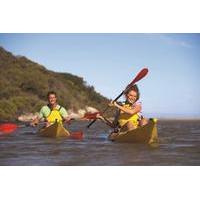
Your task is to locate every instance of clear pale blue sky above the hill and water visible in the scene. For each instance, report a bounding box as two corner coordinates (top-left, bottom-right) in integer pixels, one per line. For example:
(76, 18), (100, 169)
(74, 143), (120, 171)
(0, 33), (200, 118)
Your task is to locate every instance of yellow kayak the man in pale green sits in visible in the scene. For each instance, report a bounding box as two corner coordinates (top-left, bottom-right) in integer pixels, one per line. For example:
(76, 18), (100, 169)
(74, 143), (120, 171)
(39, 122), (70, 137)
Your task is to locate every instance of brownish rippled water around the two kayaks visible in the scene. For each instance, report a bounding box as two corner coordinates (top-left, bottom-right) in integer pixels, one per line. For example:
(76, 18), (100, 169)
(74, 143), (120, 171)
(0, 121), (200, 166)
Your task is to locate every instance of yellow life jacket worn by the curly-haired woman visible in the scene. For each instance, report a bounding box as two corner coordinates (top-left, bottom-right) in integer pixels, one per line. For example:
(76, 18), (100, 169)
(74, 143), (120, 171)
(118, 104), (139, 128)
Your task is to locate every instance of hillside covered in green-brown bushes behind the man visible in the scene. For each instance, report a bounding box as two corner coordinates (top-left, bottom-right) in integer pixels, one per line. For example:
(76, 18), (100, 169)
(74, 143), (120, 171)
(0, 47), (108, 121)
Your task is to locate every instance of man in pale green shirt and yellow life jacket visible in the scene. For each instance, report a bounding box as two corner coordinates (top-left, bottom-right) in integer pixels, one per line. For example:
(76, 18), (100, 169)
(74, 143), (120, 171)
(31, 91), (70, 126)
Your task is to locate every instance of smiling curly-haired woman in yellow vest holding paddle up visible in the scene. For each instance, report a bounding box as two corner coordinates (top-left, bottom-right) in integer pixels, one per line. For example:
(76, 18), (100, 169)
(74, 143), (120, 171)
(98, 84), (148, 132)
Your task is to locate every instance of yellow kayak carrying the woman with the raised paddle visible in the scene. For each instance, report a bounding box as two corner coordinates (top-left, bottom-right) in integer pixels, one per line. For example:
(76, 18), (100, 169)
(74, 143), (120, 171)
(108, 118), (158, 144)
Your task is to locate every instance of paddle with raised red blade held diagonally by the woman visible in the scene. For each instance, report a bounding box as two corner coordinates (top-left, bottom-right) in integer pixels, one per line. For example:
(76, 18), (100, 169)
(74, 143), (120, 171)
(87, 68), (148, 128)
